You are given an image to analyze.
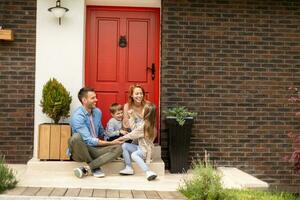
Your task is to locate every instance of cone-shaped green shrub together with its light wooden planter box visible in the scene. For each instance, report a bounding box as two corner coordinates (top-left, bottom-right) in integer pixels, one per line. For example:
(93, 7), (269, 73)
(38, 78), (72, 160)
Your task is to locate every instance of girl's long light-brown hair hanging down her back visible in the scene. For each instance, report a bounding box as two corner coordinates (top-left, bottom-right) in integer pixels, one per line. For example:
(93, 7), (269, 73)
(144, 103), (156, 140)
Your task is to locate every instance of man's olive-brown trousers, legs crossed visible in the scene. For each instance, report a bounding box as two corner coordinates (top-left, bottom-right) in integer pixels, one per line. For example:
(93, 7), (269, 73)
(68, 133), (122, 170)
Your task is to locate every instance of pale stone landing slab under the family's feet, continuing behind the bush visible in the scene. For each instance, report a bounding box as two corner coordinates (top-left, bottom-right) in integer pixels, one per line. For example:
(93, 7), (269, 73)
(9, 164), (269, 191)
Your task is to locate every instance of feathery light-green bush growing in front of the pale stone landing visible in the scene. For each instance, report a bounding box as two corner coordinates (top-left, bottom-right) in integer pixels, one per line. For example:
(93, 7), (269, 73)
(179, 162), (227, 200)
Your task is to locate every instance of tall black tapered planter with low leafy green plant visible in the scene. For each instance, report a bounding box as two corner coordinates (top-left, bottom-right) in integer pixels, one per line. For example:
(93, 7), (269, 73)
(165, 107), (197, 173)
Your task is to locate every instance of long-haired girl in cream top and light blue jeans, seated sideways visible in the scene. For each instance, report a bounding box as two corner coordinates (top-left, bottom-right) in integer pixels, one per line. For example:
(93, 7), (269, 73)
(116, 103), (157, 181)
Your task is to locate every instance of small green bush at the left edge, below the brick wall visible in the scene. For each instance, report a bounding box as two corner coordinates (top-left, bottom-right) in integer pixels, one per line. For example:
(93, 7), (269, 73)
(0, 155), (18, 193)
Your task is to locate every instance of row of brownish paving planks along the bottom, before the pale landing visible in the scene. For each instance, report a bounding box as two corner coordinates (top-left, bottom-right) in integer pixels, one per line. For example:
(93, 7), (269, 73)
(0, 187), (186, 200)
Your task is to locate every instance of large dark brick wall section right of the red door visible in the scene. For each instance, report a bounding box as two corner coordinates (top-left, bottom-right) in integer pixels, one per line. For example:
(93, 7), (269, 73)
(161, 0), (300, 190)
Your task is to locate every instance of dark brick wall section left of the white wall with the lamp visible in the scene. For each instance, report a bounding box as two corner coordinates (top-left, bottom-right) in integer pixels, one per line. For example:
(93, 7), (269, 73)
(0, 0), (36, 163)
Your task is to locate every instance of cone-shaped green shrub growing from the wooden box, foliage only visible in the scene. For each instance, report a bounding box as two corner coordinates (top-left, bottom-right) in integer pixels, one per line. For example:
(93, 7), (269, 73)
(41, 78), (72, 124)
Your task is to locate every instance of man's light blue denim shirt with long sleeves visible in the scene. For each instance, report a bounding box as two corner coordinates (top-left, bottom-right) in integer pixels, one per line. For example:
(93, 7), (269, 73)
(70, 106), (104, 146)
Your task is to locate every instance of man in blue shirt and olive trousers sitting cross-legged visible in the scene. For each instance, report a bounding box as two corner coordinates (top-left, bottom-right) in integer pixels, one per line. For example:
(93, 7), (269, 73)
(69, 87), (122, 178)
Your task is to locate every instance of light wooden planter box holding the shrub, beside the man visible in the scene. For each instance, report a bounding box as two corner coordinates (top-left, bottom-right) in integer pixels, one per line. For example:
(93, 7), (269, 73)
(38, 124), (71, 160)
